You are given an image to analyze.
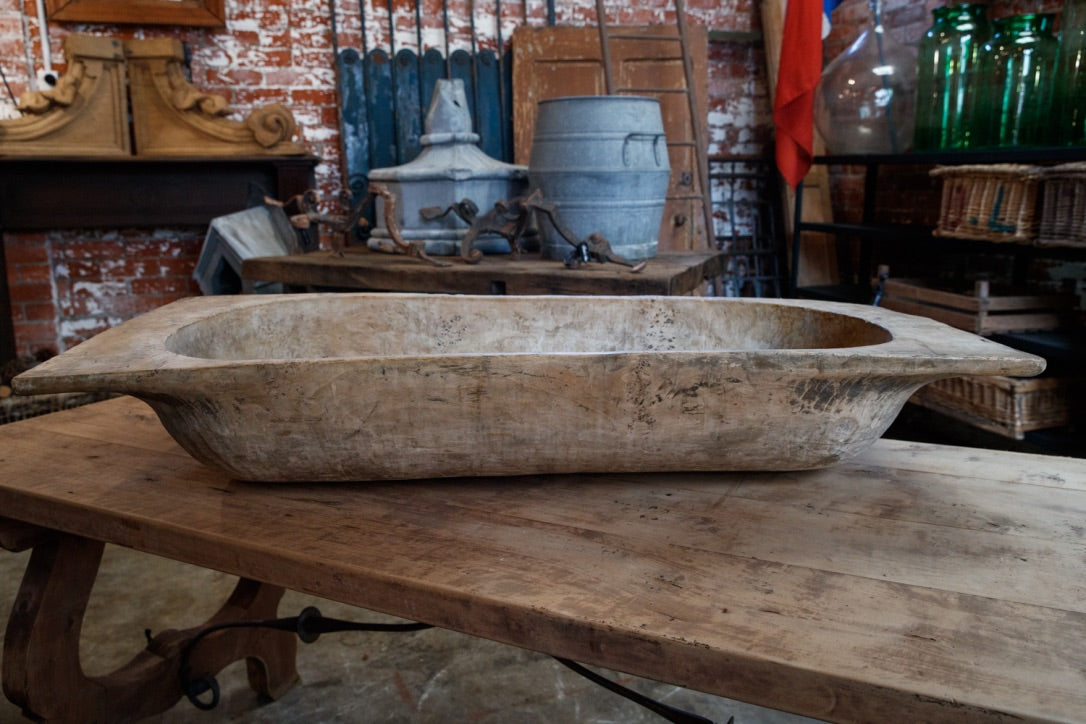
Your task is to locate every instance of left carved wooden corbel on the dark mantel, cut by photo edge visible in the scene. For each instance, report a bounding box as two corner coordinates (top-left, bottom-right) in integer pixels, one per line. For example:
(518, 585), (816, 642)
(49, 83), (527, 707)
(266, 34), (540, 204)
(0, 35), (131, 156)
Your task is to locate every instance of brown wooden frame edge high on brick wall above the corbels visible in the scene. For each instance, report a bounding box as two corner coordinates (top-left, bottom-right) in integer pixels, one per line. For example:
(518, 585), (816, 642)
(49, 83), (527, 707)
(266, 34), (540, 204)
(46, 0), (226, 27)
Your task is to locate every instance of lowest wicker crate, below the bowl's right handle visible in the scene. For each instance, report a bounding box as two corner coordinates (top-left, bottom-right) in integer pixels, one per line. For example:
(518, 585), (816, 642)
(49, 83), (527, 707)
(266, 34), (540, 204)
(909, 377), (1074, 440)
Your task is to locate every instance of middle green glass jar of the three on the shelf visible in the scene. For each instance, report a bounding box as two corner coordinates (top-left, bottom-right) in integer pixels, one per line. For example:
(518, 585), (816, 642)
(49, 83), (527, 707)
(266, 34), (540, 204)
(977, 13), (1060, 148)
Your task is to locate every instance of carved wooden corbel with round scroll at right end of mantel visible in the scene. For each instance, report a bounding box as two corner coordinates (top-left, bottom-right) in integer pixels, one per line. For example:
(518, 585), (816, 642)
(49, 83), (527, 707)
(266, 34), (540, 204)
(125, 38), (305, 156)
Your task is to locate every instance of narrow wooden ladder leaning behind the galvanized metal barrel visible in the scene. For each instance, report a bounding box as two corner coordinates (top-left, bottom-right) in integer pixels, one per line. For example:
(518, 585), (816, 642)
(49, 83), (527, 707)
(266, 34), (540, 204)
(596, 0), (717, 250)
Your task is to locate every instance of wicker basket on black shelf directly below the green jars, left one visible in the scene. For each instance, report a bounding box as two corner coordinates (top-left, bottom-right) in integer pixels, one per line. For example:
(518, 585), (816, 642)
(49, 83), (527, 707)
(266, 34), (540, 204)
(931, 164), (1041, 244)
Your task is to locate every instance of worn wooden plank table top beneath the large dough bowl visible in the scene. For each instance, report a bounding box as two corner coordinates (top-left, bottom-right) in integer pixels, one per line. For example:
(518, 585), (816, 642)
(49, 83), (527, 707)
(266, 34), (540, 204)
(0, 397), (1086, 722)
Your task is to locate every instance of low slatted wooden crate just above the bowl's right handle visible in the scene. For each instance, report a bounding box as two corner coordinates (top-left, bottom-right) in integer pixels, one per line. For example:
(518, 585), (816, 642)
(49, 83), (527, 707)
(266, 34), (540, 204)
(880, 278), (1075, 334)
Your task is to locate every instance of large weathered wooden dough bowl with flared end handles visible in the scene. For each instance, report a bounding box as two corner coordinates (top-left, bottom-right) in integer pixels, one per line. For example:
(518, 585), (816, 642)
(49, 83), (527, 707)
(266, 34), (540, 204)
(15, 294), (1045, 481)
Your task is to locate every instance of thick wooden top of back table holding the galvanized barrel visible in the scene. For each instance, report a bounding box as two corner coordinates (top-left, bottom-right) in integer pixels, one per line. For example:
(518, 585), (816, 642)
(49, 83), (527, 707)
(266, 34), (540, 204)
(241, 246), (724, 296)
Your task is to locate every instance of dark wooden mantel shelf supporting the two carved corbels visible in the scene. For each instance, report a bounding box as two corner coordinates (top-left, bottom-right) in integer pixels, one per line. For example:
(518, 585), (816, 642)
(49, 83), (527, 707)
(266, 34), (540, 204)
(0, 155), (318, 231)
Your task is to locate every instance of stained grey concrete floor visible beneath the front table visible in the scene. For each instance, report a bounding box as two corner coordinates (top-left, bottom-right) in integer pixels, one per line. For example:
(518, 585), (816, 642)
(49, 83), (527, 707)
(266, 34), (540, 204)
(0, 546), (812, 724)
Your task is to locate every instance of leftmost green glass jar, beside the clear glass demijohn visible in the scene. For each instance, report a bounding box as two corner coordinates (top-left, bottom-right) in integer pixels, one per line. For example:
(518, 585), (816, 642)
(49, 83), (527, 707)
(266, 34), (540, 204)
(913, 3), (992, 151)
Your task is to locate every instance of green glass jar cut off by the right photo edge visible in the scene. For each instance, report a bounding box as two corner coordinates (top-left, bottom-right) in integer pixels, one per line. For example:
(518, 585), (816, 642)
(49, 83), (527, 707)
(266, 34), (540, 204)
(1056, 0), (1086, 145)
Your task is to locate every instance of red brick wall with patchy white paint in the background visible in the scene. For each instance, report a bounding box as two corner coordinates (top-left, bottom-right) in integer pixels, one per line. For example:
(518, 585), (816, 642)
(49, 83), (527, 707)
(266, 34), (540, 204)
(0, 0), (1058, 353)
